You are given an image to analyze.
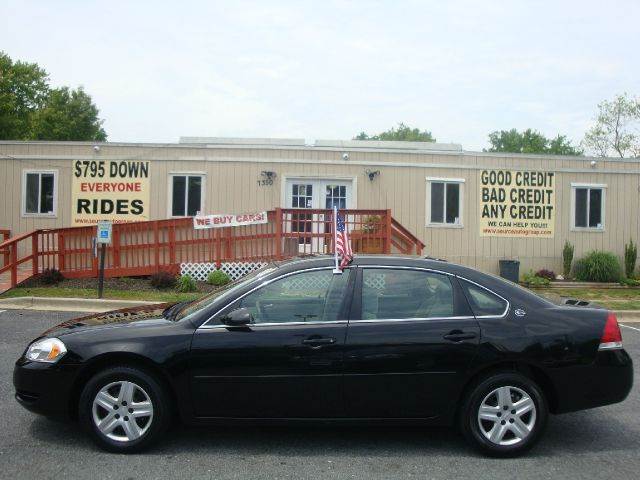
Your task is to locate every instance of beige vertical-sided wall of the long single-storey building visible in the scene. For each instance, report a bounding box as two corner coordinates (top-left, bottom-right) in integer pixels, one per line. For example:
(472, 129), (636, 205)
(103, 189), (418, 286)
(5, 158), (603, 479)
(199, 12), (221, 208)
(0, 142), (640, 272)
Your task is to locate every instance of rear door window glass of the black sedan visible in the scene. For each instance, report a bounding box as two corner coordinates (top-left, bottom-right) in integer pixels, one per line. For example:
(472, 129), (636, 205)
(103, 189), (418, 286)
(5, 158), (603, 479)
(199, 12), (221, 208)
(362, 268), (454, 320)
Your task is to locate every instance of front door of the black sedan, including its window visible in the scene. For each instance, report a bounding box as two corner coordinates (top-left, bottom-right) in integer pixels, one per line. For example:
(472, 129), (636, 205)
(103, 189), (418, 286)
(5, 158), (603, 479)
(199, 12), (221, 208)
(190, 268), (354, 418)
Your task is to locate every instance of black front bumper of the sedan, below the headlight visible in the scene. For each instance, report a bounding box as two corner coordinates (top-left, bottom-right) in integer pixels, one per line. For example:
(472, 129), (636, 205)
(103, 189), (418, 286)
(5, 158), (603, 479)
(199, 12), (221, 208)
(13, 357), (79, 417)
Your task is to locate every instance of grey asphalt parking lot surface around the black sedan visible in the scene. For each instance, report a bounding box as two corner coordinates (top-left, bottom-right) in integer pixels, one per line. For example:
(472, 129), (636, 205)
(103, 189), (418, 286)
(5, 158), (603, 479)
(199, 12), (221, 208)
(0, 310), (640, 479)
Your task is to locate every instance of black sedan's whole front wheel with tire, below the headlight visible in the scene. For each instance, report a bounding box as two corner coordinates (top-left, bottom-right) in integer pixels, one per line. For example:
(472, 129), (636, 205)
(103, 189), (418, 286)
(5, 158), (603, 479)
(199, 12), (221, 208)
(78, 366), (171, 453)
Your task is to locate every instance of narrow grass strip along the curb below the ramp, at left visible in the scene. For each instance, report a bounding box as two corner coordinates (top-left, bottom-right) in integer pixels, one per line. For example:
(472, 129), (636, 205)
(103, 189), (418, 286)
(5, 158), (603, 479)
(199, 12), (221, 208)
(0, 287), (204, 302)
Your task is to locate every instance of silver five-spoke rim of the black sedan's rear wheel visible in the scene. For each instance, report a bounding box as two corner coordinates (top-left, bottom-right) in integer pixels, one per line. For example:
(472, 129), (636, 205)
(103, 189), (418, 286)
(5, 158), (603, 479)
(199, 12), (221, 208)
(478, 386), (536, 445)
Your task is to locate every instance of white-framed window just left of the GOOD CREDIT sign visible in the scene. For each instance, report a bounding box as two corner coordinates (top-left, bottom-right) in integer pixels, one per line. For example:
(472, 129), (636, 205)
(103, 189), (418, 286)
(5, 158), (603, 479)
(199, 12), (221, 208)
(427, 177), (464, 227)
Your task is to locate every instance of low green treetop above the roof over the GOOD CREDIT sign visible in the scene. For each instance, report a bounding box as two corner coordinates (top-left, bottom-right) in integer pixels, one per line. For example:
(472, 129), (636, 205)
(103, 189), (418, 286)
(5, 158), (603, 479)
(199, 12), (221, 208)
(487, 128), (582, 155)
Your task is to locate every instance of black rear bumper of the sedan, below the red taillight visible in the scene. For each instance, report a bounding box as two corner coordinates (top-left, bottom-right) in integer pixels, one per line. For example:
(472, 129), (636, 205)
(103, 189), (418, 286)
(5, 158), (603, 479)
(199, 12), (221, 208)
(553, 349), (633, 413)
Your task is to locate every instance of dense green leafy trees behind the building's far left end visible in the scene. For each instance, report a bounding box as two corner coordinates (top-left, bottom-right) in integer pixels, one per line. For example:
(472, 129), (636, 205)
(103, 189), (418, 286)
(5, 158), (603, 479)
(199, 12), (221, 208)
(0, 52), (107, 141)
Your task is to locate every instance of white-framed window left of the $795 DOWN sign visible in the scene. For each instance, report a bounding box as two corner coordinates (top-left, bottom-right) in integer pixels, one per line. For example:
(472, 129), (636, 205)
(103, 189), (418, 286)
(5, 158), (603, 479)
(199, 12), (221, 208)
(22, 170), (58, 217)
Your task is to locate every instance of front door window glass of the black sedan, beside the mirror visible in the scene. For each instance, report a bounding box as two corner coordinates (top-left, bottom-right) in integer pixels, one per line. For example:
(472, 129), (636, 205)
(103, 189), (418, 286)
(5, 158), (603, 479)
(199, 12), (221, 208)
(234, 270), (349, 323)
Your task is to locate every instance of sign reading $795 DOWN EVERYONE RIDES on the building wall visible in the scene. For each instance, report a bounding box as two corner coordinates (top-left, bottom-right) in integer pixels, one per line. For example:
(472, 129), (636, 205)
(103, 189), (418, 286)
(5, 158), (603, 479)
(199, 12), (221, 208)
(71, 160), (150, 225)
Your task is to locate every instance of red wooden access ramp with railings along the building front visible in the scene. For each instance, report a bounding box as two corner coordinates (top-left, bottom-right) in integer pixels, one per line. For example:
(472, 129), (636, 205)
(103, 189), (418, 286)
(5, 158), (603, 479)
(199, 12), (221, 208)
(0, 208), (424, 287)
